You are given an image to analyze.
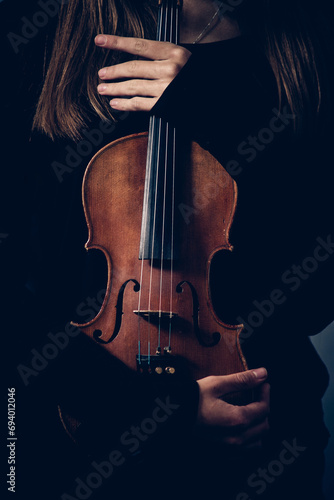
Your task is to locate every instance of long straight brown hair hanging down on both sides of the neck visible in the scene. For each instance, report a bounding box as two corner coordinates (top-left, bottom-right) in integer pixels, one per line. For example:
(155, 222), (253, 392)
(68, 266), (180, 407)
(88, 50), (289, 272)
(33, 0), (330, 140)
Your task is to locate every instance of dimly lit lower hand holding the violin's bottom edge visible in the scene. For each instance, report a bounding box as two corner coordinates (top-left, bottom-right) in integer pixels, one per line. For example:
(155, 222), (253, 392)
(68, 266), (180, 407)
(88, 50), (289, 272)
(197, 368), (270, 448)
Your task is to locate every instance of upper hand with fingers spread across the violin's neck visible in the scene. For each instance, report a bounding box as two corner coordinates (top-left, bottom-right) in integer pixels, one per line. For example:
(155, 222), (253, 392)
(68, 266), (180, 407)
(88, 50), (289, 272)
(95, 35), (191, 111)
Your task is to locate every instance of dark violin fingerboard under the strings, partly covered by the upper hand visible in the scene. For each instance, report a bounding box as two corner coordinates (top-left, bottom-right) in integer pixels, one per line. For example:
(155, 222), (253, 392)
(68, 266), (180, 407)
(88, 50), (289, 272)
(139, 0), (181, 261)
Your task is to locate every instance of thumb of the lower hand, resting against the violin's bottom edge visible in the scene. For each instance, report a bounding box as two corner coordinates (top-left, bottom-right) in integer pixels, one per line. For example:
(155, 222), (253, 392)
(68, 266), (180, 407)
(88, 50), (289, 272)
(213, 368), (268, 396)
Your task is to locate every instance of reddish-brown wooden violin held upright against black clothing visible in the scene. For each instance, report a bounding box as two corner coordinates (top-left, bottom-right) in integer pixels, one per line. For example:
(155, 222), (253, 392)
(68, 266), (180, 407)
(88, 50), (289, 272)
(76, 0), (247, 396)
